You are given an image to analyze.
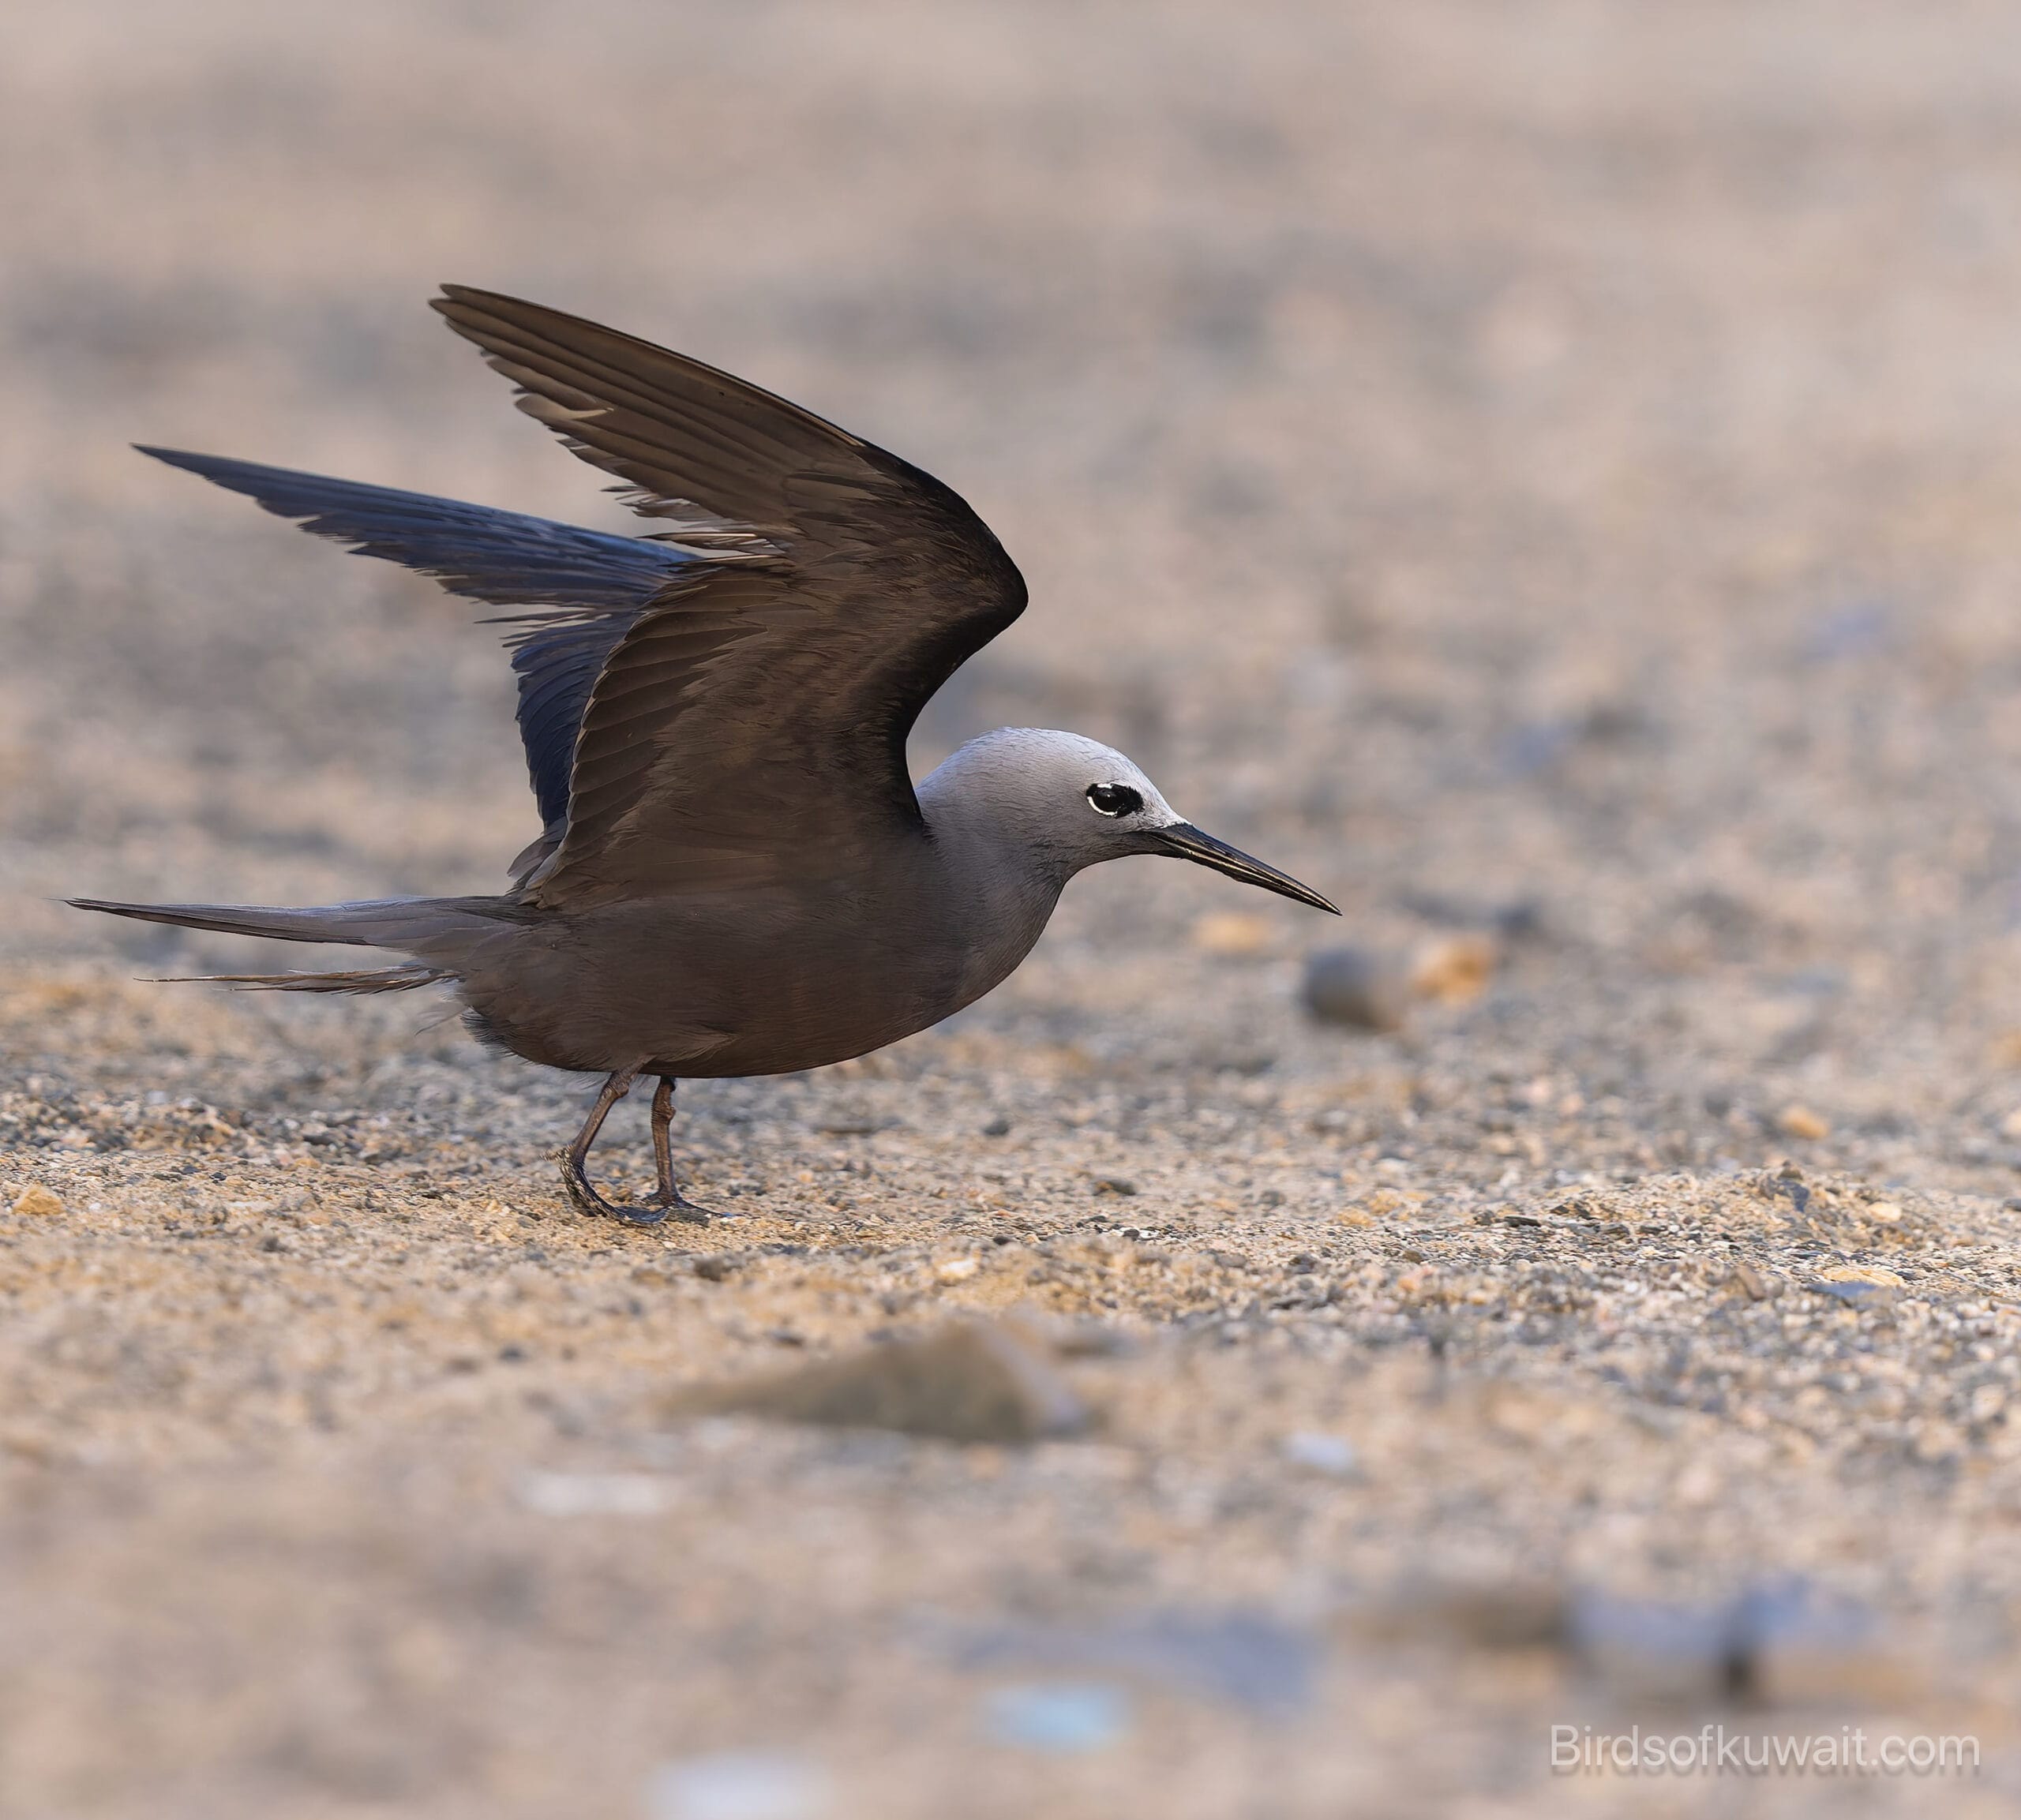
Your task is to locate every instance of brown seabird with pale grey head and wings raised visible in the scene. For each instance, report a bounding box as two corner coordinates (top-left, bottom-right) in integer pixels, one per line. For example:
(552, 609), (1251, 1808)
(66, 285), (1338, 1226)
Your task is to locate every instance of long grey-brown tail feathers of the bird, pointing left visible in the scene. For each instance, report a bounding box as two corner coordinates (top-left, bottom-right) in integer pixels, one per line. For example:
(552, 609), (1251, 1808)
(69, 897), (513, 992)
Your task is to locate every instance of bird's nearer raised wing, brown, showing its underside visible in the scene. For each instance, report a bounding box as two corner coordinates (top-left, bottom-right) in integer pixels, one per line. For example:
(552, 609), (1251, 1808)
(434, 285), (1025, 907)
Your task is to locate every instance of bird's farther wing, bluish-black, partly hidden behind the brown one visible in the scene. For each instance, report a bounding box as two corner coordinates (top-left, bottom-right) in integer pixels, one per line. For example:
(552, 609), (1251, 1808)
(141, 447), (740, 871)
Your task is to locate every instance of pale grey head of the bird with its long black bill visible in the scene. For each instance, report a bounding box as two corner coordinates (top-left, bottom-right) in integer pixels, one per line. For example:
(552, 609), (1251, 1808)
(920, 727), (1340, 915)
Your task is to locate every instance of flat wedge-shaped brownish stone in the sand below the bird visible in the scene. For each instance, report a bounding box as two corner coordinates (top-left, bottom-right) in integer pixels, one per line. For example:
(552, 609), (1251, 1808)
(673, 1321), (1091, 1442)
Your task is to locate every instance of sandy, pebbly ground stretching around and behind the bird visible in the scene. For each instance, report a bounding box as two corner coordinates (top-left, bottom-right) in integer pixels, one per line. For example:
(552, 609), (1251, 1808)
(12, 0), (2021, 1820)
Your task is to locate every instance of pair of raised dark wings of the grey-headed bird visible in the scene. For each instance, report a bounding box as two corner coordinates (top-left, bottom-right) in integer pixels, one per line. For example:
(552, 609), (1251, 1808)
(145, 285), (1025, 907)
